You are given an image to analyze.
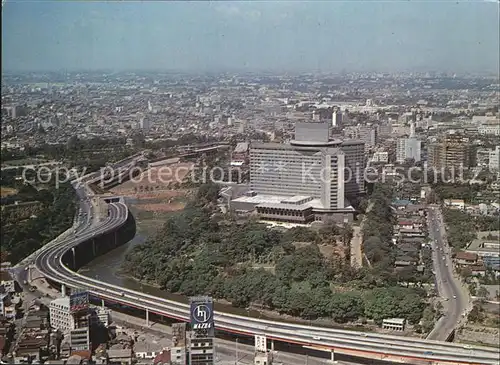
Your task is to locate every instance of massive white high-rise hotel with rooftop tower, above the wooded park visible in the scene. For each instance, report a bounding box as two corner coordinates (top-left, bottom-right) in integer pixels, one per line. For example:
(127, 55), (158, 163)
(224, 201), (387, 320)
(231, 123), (364, 223)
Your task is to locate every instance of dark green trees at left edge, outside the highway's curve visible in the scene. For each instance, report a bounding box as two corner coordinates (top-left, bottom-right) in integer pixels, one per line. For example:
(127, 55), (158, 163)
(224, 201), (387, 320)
(0, 171), (76, 264)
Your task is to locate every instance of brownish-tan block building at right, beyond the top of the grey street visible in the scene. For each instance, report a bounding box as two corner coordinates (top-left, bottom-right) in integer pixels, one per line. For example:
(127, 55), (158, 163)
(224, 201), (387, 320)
(427, 130), (471, 170)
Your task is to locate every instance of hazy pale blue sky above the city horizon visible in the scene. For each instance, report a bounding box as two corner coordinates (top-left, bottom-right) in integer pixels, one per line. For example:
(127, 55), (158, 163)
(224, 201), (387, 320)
(2, 0), (500, 72)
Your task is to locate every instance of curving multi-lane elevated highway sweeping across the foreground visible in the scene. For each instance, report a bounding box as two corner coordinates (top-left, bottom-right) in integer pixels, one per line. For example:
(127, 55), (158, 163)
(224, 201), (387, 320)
(35, 176), (499, 365)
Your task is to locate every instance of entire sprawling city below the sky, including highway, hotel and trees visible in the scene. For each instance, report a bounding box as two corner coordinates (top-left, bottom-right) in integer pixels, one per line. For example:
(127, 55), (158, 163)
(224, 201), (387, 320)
(0, 3), (500, 365)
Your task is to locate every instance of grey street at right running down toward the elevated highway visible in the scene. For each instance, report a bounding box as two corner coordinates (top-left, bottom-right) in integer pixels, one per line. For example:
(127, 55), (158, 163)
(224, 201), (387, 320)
(427, 207), (469, 340)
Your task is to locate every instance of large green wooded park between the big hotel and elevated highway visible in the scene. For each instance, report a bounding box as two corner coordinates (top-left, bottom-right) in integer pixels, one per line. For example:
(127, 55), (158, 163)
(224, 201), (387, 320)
(123, 185), (425, 323)
